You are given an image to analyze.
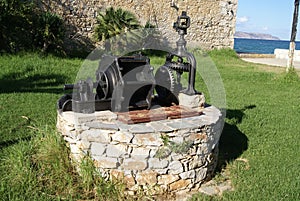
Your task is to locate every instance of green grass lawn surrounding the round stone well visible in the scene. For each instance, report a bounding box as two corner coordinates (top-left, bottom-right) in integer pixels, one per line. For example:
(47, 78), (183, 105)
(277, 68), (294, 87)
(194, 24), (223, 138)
(0, 50), (300, 200)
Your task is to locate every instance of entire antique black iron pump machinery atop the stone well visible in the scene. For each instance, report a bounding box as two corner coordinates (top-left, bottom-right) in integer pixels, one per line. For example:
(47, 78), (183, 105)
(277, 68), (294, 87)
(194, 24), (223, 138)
(58, 12), (197, 113)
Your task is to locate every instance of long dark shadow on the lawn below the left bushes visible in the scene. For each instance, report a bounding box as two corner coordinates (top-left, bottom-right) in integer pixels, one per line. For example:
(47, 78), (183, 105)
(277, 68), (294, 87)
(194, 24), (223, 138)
(0, 71), (67, 94)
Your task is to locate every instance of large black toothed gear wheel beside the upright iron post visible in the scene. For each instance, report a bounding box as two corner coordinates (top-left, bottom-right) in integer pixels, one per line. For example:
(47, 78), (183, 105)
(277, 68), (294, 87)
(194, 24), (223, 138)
(155, 66), (178, 105)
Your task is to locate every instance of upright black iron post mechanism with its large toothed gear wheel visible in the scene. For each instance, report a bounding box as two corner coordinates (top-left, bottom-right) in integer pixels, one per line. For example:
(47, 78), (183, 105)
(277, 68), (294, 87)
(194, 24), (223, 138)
(155, 11), (198, 103)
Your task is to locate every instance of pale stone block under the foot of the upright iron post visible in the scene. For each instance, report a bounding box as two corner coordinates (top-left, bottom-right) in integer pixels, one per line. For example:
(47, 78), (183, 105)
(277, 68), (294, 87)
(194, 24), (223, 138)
(178, 93), (205, 108)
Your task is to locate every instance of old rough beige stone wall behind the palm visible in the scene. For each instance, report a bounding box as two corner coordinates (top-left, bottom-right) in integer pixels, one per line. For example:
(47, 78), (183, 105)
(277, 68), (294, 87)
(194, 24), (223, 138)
(41, 0), (238, 49)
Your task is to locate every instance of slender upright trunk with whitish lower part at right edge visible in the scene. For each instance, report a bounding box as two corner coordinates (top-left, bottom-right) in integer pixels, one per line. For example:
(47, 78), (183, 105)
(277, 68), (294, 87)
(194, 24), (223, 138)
(286, 0), (299, 71)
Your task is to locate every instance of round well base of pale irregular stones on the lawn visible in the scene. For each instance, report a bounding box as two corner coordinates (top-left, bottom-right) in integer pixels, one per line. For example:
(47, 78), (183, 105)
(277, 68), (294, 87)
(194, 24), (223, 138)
(57, 106), (223, 194)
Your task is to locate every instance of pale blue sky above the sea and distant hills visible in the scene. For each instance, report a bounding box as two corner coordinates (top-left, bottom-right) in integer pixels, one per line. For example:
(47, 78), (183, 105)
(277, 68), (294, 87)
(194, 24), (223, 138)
(236, 0), (300, 41)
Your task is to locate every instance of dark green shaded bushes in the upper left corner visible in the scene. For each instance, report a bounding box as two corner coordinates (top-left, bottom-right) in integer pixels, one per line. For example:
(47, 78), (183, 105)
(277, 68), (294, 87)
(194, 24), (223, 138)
(0, 0), (64, 53)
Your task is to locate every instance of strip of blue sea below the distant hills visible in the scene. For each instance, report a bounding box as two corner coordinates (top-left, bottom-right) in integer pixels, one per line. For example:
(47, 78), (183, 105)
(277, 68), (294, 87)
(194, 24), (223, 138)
(234, 38), (300, 54)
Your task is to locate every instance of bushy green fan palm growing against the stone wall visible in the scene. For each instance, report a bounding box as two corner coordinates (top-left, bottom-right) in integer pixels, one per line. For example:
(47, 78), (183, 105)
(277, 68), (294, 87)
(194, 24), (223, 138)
(95, 7), (140, 50)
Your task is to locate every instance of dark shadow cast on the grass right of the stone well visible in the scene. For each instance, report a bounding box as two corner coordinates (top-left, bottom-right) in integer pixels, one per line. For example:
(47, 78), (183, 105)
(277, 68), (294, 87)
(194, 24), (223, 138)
(216, 105), (256, 172)
